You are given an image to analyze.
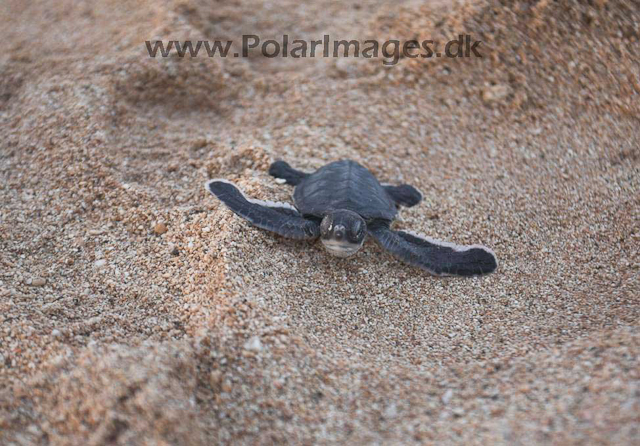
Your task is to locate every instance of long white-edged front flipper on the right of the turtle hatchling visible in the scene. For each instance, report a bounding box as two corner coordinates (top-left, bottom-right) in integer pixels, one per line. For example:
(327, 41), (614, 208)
(369, 225), (498, 276)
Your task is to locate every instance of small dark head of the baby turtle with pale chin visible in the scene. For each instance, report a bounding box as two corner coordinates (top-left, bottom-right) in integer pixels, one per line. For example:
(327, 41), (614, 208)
(320, 209), (367, 257)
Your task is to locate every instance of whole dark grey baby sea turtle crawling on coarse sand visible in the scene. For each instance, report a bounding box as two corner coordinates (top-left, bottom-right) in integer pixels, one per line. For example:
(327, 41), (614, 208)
(206, 160), (498, 276)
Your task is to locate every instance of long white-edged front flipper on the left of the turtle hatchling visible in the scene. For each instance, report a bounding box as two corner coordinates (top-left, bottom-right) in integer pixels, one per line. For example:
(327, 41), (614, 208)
(206, 179), (320, 240)
